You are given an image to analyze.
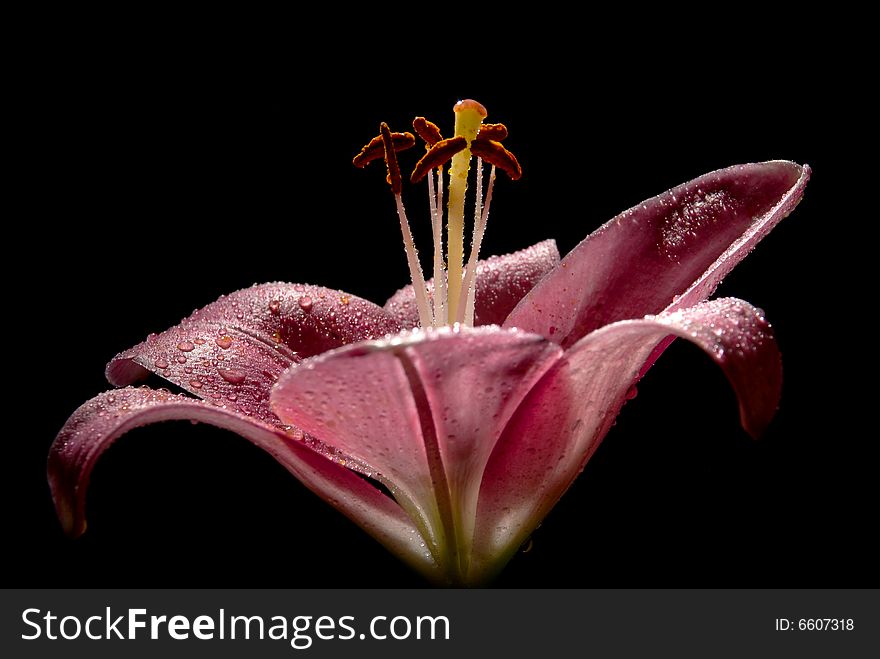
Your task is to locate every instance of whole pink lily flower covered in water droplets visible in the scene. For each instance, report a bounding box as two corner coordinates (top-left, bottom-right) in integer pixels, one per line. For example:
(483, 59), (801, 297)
(49, 100), (810, 584)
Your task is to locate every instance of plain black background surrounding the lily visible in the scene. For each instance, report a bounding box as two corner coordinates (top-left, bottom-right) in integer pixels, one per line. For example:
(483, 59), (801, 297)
(12, 35), (878, 587)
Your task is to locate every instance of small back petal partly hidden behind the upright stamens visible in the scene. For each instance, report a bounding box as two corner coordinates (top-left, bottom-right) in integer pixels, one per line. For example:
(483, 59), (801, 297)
(385, 240), (559, 329)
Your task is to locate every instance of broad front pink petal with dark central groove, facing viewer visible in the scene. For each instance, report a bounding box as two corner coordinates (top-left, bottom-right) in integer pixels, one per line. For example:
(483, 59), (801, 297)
(272, 327), (562, 576)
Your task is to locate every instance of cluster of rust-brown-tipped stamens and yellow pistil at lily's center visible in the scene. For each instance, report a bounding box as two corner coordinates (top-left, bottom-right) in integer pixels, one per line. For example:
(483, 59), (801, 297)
(352, 99), (522, 327)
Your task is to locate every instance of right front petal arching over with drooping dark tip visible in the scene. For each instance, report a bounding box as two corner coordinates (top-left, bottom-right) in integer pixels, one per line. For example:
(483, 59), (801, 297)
(474, 298), (782, 584)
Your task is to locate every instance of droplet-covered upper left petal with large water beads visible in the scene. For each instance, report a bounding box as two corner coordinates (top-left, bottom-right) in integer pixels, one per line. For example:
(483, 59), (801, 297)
(107, 284), (399, 423)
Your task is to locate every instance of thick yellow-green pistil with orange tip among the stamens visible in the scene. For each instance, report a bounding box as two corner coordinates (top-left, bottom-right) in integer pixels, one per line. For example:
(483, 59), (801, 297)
(447, 99), (486, 318)
